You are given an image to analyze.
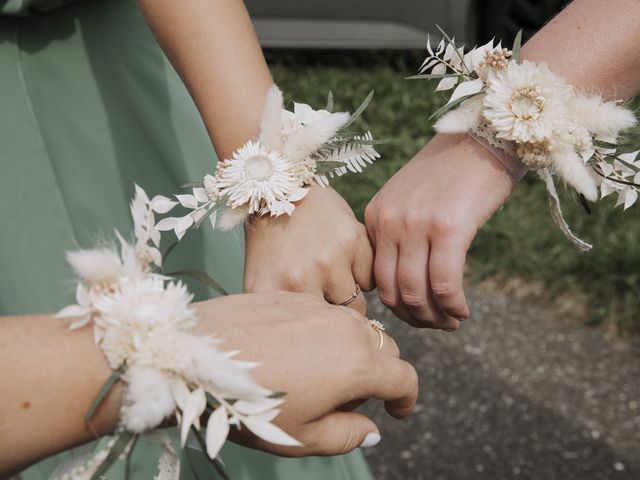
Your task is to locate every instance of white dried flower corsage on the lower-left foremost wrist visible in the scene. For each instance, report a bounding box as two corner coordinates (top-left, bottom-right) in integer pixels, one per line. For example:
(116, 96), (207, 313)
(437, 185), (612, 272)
(57, 185), (299, 480)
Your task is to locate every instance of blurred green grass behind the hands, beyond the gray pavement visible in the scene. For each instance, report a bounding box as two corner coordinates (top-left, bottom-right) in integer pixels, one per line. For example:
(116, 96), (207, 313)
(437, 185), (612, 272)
(267, 52), (640, 333)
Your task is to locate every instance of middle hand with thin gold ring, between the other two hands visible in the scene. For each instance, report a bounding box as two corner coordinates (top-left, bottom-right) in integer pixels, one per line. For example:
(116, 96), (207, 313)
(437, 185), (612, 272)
(244, 186), (374, 315)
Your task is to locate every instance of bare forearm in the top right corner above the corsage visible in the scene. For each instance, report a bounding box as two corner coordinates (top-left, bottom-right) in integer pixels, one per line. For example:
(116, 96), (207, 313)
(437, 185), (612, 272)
(522, 0), (640, 100)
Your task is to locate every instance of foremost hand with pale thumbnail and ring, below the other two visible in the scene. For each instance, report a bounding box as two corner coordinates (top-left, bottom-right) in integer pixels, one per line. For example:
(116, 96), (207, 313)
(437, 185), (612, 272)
(195, 292), (418, 456)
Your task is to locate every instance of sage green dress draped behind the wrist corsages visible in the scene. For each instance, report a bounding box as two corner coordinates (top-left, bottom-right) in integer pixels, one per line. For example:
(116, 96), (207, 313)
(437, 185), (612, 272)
(0, 0), (371, 480)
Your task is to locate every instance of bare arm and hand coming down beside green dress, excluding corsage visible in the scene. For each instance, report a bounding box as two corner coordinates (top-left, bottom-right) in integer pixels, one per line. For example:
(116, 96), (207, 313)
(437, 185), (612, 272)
(139, 0), (373, 313)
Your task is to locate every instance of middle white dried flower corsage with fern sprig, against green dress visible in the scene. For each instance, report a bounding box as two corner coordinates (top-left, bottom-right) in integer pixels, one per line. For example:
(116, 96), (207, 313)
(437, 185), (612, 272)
(156, 85), (380, 239)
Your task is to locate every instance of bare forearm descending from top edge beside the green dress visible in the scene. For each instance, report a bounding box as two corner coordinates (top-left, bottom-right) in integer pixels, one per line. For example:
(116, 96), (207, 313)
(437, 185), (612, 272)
(139, 0), (273, 159)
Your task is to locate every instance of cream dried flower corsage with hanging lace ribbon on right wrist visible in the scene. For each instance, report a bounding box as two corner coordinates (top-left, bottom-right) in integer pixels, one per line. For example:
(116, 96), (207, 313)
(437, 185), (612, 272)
(409, 30), (640, 250)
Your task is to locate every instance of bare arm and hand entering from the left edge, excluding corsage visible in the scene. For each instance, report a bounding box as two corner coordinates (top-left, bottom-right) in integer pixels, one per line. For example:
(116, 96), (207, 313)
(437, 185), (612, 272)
(0, 292), (418, 472)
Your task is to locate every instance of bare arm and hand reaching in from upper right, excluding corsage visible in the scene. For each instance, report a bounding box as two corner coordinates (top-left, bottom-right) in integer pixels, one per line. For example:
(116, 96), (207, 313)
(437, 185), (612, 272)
(365, 0), (640, 330)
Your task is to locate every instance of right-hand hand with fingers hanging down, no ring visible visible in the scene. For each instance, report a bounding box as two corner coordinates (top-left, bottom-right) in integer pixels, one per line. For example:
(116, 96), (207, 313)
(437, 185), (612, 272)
(365, 134), (515, 330)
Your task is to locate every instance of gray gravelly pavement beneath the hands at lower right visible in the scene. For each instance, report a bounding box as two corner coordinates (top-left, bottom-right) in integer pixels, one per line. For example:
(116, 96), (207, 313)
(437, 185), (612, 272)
(365, 291), (640, 480)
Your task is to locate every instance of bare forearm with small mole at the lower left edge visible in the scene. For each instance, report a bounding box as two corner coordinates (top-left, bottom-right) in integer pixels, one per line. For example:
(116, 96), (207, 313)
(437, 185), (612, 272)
(0, 315), (121, 477)
